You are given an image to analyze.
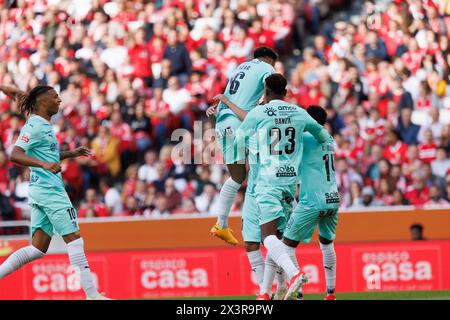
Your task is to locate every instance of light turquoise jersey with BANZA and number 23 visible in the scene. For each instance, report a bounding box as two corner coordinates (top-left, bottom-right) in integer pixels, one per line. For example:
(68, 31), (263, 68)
(235, 100), (330, 186)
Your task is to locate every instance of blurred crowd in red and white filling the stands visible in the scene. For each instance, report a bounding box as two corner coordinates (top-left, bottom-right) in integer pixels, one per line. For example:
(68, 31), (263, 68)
(0, 0), (450, 228)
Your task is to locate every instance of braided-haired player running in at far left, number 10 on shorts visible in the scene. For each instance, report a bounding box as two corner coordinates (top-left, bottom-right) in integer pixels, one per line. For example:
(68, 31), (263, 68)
(0, 86), (110, 300)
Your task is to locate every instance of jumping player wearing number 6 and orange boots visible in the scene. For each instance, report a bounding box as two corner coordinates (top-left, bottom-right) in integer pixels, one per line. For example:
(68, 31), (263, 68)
(210, 47), (278, 245)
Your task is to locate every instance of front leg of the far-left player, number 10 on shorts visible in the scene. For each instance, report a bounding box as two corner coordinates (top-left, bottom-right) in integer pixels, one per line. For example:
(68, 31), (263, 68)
(44, 198), (107, 300)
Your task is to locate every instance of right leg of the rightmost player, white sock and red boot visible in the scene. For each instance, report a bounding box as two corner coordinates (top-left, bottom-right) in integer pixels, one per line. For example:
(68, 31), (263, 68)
(319, 209), (338, 300)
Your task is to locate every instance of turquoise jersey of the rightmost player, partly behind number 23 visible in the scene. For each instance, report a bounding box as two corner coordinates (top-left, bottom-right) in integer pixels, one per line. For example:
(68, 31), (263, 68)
(299, 133), (339, 209)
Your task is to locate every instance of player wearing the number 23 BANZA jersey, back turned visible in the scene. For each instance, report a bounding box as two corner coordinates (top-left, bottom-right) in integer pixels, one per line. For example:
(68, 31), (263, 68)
(227, 74), (330, 299)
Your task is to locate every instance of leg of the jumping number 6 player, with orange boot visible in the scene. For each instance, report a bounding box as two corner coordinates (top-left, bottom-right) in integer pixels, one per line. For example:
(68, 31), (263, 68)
(210, 115), (246, 245)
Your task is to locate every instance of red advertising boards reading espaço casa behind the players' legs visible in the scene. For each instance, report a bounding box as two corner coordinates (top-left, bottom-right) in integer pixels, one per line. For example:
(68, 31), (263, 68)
(0, 241), (450, 299)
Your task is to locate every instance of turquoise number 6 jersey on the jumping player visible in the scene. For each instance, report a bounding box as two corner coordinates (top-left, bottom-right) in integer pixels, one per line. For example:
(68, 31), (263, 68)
(217, 59), (275, 120)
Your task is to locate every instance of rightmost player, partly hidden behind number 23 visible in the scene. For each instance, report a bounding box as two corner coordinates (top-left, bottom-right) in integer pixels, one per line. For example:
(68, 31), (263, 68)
(283, 106), (340, 300)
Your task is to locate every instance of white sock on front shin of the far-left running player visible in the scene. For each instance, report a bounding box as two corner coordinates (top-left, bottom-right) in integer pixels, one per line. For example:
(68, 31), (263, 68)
(67, 238), (99, 298)
